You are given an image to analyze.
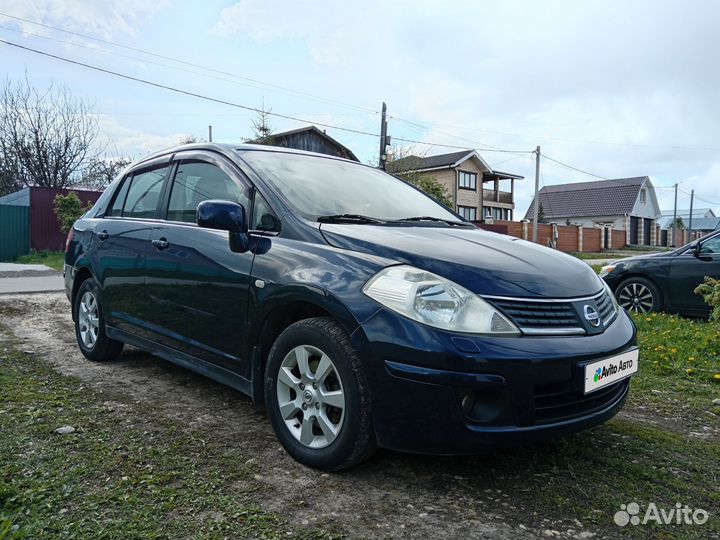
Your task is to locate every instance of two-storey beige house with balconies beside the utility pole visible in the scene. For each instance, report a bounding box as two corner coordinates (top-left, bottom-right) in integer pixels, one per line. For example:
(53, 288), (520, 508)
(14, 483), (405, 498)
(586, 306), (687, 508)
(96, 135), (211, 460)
(387, 150), (523, 221)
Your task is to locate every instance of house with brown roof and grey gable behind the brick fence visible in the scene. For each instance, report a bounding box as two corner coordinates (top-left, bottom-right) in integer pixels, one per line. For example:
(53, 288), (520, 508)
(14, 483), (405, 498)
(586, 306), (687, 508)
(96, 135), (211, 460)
(525, 176), (662, 246)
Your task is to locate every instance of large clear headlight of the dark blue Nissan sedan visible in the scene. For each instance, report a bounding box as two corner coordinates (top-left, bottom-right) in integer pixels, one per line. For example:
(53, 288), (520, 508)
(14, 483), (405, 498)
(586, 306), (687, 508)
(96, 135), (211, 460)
(363, 265), (520, 335)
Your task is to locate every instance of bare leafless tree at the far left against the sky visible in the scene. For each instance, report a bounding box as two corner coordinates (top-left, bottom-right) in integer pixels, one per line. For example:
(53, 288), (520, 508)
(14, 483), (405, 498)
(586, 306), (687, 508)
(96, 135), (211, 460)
(0, 77), (98, 188)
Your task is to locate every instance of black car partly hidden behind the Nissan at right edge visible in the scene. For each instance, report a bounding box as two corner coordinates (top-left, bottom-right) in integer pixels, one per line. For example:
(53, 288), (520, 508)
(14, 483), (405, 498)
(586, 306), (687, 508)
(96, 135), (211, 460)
(600, 231), (720, 317)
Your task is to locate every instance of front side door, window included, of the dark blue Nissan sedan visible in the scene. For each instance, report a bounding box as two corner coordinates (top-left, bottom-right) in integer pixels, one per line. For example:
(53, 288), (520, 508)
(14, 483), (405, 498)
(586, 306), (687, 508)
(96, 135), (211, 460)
(147, 152), (253, 376)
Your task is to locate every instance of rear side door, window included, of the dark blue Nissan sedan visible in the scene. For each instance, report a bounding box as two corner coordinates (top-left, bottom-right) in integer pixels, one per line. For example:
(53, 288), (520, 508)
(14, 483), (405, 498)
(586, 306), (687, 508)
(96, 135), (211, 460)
(94, 160), (171, 337)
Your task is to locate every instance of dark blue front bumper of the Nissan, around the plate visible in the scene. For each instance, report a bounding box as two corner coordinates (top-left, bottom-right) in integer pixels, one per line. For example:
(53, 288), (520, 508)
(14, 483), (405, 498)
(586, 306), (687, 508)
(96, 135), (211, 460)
(355, 310), (636, 454)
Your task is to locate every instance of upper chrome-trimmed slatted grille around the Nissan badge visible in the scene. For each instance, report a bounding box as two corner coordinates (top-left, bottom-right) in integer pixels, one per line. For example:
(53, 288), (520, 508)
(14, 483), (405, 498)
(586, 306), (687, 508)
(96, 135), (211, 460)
(484, 289), (616, 335)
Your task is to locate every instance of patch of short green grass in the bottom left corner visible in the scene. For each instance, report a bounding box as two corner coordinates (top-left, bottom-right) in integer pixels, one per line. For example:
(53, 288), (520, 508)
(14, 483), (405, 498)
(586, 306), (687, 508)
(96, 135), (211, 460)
(0, 344), (340, 540)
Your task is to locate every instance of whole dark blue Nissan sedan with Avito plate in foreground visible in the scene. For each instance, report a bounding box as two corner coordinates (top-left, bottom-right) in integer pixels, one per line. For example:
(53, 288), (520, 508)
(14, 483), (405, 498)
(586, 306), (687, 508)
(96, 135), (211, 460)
(65, 144), (638, 470)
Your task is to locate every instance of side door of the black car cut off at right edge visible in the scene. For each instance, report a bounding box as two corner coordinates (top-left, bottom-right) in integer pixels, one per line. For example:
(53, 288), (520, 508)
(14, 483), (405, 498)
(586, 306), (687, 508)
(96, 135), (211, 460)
(668, 234), (720, 313)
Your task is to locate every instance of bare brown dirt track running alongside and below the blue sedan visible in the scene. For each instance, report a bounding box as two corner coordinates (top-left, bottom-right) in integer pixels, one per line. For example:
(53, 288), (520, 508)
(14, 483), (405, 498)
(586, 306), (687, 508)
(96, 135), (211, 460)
(0, 293), (668, 539)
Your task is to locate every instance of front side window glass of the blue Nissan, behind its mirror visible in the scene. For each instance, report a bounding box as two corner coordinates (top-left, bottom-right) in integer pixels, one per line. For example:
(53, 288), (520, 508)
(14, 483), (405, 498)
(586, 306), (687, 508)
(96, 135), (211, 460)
(167, 161), (250, 223)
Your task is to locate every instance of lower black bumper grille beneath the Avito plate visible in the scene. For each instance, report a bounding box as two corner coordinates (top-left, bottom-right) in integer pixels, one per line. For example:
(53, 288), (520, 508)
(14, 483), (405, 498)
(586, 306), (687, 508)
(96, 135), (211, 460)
(534, 379), (629, 425)
